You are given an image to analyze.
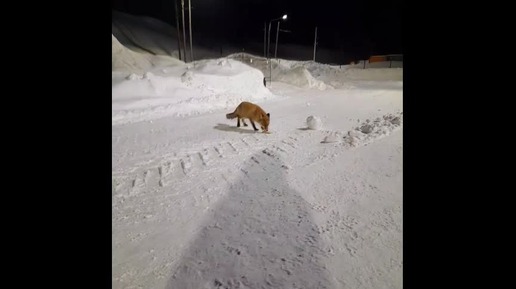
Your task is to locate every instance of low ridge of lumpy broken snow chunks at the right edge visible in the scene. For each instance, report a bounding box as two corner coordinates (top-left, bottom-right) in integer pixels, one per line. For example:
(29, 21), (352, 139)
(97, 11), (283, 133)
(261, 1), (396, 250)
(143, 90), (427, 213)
(344, 112), (403, 147)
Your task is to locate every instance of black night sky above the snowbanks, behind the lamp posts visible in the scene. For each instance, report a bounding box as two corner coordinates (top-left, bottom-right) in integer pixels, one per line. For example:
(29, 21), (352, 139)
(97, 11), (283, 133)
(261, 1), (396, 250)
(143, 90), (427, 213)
(113, 0), (402, 58)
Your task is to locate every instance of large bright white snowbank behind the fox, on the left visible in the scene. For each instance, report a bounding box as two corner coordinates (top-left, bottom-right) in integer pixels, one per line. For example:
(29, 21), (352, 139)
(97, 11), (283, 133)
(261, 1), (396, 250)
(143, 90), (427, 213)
(112, 58), (277, 125)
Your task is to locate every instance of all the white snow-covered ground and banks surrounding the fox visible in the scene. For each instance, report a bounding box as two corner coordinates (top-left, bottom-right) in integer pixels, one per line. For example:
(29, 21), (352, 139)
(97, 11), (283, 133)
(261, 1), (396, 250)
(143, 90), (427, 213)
(112, 11), (403, 289)
